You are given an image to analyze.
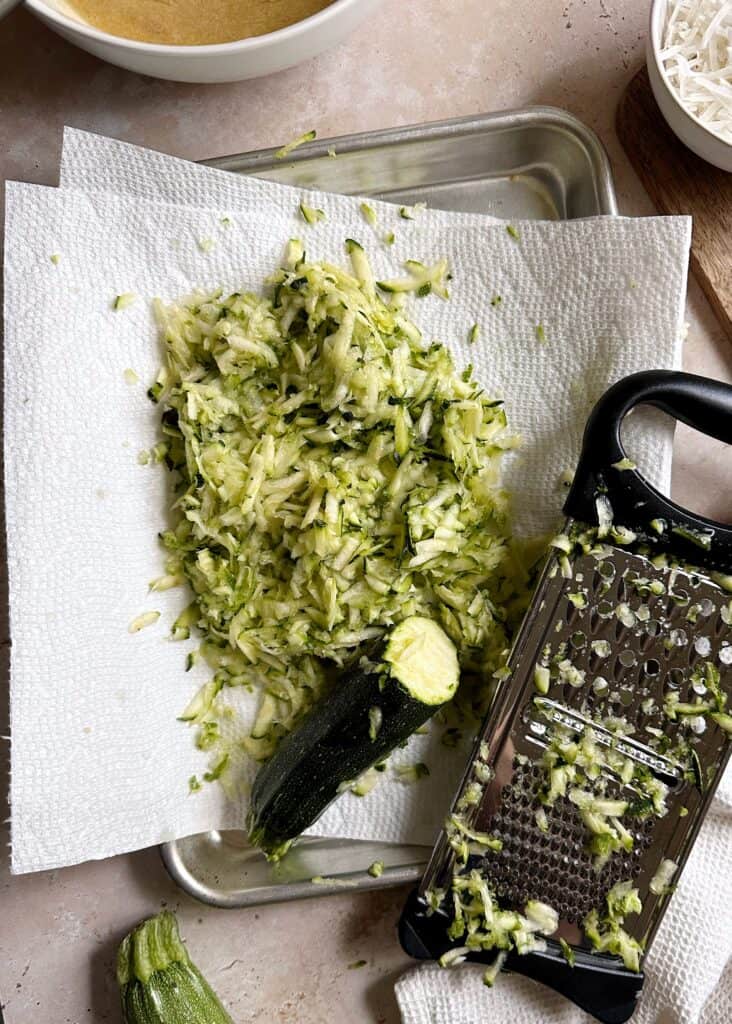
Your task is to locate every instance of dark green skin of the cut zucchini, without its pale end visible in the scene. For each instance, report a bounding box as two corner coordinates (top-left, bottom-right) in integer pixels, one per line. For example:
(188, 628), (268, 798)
(248, 668), (441, 859)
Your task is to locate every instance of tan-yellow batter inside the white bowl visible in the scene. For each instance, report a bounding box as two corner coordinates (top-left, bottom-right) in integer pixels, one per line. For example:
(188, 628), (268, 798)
(71, 0), (331, 46)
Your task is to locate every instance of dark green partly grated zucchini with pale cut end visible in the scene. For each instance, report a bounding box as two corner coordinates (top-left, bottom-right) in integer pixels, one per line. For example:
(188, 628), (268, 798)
(248, 615), (460, 860)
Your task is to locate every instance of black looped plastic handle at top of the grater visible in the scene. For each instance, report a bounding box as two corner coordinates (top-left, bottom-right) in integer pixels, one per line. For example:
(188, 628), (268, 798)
(564, 370), (732, 571)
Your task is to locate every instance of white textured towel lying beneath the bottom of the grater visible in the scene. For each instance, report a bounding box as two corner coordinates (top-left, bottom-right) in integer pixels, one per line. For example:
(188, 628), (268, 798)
(396, 801), (732, 1024)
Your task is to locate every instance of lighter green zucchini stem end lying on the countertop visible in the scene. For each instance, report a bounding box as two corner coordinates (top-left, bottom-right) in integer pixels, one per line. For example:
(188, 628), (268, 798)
(117, 910), (233, 1024)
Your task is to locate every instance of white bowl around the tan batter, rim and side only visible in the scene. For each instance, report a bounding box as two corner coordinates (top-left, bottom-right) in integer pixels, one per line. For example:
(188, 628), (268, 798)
(27, 0), (380, 82)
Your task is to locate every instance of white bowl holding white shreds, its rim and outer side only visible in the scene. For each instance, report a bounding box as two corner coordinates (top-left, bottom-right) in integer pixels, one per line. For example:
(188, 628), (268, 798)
(646, 0), (732, 171)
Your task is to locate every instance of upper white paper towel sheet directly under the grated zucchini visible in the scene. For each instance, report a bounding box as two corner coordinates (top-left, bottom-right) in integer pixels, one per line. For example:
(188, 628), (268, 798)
(5, 159), (689, 871)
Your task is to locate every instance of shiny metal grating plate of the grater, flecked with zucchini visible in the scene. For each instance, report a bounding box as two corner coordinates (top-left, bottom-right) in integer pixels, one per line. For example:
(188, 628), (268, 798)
(421, 523), (732, 945)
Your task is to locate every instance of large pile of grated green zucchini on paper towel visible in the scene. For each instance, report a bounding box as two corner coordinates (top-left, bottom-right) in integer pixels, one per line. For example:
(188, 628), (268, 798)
(149, 241), (526, 776)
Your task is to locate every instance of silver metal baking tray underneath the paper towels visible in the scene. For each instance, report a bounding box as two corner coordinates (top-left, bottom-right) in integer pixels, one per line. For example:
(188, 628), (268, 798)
(161, 106), (617, 907)
